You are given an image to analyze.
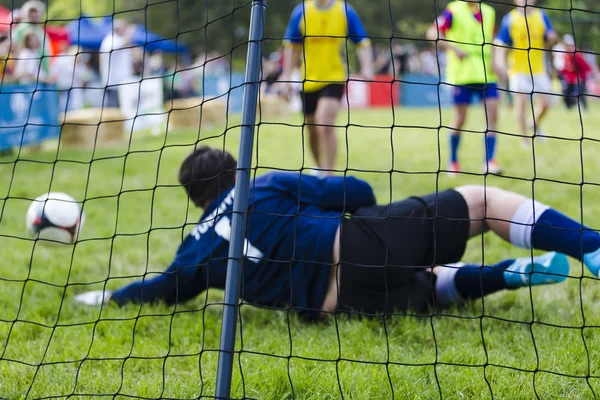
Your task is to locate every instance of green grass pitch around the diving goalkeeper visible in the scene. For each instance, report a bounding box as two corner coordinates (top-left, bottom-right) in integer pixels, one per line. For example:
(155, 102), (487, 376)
(0, 101), (600, 399)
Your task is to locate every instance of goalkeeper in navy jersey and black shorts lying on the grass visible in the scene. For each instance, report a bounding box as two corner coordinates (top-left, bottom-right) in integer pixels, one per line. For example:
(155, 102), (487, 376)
(77, 147), (600, 319)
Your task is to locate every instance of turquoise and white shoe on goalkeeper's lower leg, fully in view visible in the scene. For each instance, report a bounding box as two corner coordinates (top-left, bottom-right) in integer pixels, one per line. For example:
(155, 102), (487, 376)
(504, 252), (569, 287)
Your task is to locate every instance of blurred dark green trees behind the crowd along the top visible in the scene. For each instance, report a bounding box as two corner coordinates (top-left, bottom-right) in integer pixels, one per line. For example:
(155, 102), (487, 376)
(0, 0), (600, 58)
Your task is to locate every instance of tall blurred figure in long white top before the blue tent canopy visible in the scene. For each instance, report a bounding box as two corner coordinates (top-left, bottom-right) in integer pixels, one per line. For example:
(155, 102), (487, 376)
(100, 19), (136, 107)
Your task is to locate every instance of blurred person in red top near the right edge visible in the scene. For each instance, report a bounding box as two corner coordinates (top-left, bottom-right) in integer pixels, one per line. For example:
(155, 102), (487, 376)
(560, 35), (598, 110)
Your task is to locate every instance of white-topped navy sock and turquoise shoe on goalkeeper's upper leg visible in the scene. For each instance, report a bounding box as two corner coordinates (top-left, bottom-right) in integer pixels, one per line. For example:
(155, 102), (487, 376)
(510, 201), (600, 276)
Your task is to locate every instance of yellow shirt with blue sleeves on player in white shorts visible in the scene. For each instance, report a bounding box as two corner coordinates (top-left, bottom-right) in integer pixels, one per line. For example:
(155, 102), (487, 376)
(496, 9), (554, 75)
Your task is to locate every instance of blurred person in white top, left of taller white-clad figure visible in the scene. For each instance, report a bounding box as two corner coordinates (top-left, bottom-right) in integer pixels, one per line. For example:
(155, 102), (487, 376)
(50, 46), (92, 118)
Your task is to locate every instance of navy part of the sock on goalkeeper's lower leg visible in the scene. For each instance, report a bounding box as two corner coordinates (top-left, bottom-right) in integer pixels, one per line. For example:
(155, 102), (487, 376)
(454, 260), (515, 300)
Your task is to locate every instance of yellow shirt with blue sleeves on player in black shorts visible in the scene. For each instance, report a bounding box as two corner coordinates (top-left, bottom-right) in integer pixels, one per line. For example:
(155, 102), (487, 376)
(284, 0), (369, 92)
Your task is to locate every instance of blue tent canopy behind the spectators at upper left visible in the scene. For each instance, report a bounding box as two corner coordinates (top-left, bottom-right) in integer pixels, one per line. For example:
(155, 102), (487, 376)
(67, 16), (188, 53)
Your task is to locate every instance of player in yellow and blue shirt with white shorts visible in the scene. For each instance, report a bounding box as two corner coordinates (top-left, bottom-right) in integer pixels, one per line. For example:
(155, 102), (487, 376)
(494, 0), (558, 145)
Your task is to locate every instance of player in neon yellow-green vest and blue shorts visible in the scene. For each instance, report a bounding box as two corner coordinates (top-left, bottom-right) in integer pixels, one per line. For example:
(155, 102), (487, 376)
(426, 1), (502, 174)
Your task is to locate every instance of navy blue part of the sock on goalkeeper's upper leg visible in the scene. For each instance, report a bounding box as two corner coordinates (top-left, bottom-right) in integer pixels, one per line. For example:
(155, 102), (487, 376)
(531, 208), (600, 260)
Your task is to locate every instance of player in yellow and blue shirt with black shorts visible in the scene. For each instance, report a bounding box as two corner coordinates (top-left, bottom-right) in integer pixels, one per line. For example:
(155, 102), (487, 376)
(281, 0), (373, 175)
